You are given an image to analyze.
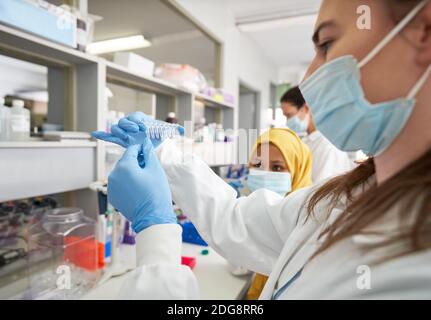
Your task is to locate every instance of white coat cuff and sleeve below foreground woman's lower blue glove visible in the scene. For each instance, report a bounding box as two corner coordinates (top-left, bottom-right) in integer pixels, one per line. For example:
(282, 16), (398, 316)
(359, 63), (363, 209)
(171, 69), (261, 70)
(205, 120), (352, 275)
(119, 224), (199, 300)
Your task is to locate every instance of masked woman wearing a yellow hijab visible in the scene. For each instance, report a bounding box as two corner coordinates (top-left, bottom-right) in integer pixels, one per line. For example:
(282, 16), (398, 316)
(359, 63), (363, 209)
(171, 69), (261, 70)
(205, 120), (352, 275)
(247, 128), (312, 300)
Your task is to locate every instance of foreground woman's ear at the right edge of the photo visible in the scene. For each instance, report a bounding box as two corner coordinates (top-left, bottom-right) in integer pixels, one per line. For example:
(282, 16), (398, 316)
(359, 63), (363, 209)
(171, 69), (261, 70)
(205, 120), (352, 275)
(417, 1), (431, 66)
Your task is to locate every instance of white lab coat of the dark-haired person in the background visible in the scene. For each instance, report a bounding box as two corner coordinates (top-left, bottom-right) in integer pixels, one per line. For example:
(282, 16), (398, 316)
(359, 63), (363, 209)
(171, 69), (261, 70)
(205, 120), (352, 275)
(302, 130), (353, 184)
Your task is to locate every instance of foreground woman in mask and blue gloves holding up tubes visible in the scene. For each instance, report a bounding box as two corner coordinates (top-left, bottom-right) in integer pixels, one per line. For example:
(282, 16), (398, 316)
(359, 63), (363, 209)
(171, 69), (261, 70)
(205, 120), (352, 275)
(96, 0), (431, 299)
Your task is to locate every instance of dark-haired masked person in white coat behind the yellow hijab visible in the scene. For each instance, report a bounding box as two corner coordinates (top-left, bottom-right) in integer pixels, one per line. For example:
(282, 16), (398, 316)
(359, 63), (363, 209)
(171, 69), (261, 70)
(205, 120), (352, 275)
(280, 86), (353, 183)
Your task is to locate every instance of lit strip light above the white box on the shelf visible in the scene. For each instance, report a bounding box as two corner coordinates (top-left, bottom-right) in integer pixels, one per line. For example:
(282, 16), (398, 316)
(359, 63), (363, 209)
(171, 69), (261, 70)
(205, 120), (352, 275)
(105, 61), (191, 95)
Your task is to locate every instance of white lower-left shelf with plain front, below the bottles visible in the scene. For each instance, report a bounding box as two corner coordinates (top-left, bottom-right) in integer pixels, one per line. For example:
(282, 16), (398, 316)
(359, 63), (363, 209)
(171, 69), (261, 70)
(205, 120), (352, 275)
(0, 141), (97, 202)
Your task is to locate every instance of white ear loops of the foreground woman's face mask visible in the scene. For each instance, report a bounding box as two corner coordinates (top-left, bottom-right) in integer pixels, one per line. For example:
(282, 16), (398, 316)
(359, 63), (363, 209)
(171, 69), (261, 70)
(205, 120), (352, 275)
(358, 0), (431, 99)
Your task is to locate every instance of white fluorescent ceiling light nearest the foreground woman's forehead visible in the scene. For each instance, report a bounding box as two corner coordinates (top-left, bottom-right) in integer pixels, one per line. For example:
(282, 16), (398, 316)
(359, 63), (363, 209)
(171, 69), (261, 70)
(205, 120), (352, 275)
(237, 14), (317, 32)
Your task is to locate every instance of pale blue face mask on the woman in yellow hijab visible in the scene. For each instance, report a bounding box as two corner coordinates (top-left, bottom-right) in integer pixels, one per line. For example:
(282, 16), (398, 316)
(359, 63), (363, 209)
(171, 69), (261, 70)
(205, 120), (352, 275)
(247, 169), (292, 197)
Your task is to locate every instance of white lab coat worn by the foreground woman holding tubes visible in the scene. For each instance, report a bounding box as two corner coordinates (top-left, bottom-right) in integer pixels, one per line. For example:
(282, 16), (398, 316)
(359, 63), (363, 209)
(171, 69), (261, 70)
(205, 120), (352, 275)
(121, 142), (431, 299)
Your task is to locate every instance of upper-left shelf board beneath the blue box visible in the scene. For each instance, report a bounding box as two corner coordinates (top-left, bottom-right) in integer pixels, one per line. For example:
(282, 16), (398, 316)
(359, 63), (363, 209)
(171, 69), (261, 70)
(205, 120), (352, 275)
(0, 24), (99, 65)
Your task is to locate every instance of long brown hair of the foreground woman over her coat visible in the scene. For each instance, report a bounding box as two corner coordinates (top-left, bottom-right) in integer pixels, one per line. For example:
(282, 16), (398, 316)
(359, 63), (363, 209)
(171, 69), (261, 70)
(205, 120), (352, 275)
(307, 0), (431, 262)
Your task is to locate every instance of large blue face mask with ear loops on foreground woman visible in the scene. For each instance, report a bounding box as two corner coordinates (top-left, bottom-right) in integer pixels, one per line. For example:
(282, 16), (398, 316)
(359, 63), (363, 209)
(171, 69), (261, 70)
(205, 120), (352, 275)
(300, 0), (431, 156)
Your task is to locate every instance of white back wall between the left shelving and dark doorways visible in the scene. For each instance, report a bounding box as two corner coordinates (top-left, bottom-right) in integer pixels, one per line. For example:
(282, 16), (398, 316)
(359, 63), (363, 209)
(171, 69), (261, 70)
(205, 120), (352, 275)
(176, 0), (278, 128)
